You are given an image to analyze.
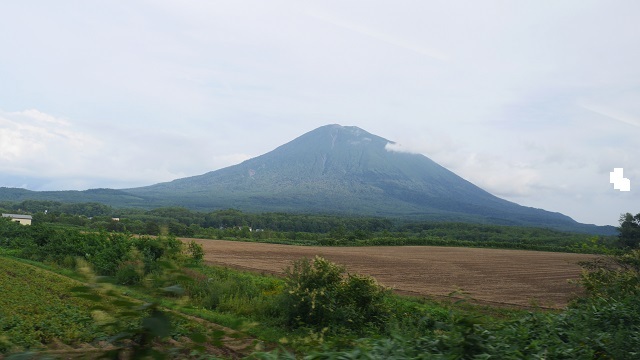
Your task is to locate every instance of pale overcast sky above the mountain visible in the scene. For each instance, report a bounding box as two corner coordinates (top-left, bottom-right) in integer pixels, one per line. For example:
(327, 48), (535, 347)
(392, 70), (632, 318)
(0, 0), (640, 225)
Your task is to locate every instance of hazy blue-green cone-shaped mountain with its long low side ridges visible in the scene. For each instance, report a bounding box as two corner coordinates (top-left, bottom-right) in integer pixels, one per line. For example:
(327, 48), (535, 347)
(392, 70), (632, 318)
(0, 125), (611, 233)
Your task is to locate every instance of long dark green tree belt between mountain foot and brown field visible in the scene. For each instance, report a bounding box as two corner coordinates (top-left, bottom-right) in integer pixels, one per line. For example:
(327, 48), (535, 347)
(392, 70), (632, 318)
(0, 201), (620, 254)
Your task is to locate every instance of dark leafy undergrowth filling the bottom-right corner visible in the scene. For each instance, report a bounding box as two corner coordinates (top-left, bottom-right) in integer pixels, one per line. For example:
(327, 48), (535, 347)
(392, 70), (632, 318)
(254, 250), (640, 359)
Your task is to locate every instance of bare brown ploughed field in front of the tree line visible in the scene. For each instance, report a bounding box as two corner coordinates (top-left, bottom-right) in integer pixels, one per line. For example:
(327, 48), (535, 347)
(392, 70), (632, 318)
(184, 239), (594, 308)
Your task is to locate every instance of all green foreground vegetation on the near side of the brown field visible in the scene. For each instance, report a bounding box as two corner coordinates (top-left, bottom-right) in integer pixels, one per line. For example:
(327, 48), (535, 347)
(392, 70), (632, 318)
(0, 208), (640, 359)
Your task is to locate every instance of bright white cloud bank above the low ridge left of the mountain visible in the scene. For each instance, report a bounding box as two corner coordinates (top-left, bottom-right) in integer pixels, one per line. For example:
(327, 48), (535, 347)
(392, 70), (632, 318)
(0, 109), (268, 190)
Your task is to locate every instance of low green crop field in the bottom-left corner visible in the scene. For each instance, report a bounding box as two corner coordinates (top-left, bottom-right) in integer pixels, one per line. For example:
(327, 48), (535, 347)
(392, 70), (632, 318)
(0, 256), (262, 359)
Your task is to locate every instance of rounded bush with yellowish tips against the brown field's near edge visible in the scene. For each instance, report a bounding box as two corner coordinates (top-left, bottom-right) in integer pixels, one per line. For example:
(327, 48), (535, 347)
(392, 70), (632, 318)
(282, 256), (390, 333)
